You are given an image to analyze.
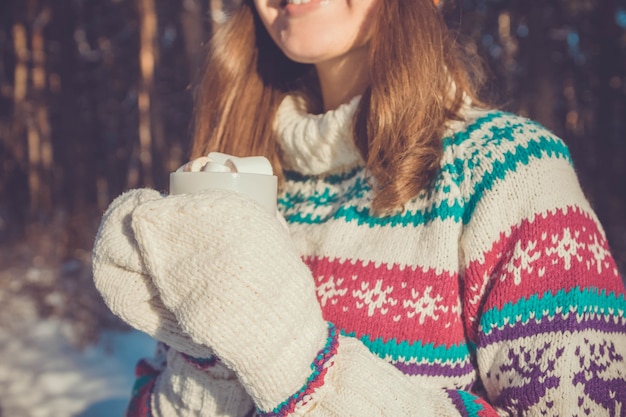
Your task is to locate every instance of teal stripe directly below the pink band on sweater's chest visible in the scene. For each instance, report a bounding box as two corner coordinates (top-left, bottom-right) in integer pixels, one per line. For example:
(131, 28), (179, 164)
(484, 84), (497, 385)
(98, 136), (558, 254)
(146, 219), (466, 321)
(341, 331), (470, 364)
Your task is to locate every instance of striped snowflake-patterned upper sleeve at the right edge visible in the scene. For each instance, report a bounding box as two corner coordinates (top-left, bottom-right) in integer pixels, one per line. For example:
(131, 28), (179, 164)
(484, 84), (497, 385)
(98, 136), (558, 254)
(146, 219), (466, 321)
(454, 112), (626, 416)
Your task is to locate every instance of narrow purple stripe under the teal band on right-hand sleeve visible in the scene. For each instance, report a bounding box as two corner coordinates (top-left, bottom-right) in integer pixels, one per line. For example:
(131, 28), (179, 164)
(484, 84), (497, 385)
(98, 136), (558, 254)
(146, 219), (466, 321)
(479, 313), (626, 347)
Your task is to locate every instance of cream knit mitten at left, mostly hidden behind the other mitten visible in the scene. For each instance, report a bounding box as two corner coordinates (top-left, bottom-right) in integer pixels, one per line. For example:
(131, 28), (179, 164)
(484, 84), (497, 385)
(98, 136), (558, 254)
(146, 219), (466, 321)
(92, 189), (211, 357)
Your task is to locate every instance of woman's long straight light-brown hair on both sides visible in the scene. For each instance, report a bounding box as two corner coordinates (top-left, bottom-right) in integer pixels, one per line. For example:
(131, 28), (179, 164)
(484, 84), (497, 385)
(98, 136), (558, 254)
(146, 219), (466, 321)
(192, 0), (482, 214)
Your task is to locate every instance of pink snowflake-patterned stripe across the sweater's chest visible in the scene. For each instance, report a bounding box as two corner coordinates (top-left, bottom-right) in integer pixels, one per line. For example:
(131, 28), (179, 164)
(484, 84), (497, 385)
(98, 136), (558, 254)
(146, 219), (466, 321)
(305, 258), (464, 346)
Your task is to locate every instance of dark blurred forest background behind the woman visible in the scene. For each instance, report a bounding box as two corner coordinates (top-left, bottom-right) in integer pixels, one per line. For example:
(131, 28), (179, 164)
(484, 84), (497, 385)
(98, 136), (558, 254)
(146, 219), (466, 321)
(0, 0), (626, 343)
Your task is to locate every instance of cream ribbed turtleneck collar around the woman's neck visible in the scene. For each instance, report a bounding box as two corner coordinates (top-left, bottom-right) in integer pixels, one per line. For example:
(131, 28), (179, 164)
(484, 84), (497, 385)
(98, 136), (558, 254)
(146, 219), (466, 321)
(274, 96), (363, 175)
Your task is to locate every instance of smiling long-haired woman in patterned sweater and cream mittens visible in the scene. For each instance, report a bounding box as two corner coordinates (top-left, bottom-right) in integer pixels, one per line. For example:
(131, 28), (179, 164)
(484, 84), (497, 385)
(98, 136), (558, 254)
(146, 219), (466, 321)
(94, 0), (626, 416)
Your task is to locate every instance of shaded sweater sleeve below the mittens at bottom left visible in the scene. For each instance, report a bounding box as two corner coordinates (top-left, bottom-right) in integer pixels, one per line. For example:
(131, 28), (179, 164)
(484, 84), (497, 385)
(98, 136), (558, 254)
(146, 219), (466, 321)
(126, 342), (254, 417)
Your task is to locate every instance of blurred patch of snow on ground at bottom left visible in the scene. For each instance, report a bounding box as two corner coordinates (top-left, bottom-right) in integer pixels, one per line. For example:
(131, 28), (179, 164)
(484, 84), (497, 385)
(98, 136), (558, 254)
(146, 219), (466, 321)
(0, 319), (155, 417)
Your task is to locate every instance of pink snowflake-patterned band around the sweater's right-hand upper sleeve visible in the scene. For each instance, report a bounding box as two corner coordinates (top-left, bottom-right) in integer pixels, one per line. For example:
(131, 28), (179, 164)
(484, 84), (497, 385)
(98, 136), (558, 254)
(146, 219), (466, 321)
(465, 208), (623, 336)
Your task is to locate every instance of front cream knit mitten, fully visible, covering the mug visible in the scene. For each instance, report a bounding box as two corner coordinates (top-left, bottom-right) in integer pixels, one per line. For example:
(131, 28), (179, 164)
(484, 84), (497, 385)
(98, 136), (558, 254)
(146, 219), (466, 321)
(132, 190), (332, 411)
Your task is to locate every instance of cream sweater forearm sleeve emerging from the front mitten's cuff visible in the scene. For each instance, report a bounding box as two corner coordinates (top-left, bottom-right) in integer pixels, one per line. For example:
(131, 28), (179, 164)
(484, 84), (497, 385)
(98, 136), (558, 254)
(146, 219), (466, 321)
(251, 336), (498, 417)
